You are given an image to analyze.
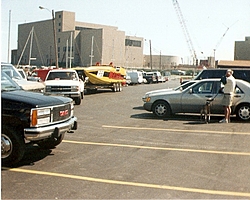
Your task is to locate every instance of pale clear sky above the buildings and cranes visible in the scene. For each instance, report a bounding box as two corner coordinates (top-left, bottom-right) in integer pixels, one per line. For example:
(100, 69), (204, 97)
(1, 0), (250, 62)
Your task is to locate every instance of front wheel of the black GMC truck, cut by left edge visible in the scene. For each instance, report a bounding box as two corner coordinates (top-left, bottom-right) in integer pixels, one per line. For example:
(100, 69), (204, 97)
(1, 126), (25, 166)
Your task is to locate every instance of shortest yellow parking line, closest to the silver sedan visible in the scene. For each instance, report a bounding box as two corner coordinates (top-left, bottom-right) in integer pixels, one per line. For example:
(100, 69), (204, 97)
(102, 125), (250, 135)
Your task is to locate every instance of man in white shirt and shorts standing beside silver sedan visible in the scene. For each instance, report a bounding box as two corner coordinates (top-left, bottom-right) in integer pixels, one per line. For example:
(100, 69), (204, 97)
(219, 69), (236, 123)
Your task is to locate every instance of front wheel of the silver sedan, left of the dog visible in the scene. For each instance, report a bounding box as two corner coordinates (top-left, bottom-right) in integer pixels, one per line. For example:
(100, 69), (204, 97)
(152, 101), (171, 118)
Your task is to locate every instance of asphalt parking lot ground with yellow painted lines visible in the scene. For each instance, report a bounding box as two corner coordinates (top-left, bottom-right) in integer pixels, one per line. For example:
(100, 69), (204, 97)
(2, 79), (250, 199)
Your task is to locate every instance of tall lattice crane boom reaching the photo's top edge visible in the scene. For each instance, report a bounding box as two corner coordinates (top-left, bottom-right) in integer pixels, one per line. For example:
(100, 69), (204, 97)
(173, 0), (198, 64)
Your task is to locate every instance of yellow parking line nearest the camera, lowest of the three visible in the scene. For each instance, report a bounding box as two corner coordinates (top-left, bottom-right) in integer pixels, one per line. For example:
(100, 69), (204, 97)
(2, 167), (250, 197)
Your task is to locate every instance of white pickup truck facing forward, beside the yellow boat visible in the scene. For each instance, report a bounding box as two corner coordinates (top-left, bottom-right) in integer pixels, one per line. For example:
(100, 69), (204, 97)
(44, 69), (84, 105)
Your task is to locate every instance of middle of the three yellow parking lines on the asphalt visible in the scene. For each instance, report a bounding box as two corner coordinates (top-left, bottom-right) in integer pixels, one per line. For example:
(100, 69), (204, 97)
(63, 140), (250, 156)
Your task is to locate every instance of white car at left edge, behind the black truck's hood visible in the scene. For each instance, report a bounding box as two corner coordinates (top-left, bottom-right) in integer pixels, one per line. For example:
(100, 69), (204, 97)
(1, 63), (45, 92)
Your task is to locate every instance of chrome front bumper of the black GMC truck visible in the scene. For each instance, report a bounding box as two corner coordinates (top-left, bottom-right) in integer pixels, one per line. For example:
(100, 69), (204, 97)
(24, 117), (77, 141)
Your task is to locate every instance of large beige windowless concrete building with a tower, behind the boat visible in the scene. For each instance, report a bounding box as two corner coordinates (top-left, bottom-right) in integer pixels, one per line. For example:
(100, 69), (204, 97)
(12, 11), (143, 68)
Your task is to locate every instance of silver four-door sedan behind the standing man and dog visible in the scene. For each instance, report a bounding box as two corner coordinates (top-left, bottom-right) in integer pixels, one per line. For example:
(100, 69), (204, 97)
(142, 79), (250, 121)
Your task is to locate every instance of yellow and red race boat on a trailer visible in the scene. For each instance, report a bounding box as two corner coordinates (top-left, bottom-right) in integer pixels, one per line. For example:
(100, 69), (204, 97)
(73, 63), (126, 92)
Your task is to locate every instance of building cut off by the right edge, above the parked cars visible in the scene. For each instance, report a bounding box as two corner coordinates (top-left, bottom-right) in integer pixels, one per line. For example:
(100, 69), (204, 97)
(234, 37), (250, 60)
